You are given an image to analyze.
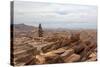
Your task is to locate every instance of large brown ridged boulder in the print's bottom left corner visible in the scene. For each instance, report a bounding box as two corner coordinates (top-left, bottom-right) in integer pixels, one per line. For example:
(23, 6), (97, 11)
(13, 44), (37, 65)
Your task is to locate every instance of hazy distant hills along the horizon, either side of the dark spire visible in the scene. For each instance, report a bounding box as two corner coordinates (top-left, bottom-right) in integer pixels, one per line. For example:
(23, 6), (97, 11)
(14, 24), (95, 32)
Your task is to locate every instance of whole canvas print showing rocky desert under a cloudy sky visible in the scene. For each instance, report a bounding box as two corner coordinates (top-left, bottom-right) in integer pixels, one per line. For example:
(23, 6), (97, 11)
(10, 1), (98, 66)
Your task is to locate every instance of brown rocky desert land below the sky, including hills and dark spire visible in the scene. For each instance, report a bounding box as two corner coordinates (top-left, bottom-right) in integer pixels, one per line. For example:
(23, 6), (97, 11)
(11, 24), (97, 66)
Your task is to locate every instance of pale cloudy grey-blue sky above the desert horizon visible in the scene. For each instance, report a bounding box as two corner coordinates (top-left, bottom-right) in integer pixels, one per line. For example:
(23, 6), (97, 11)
(14, 1), (97, 29)
